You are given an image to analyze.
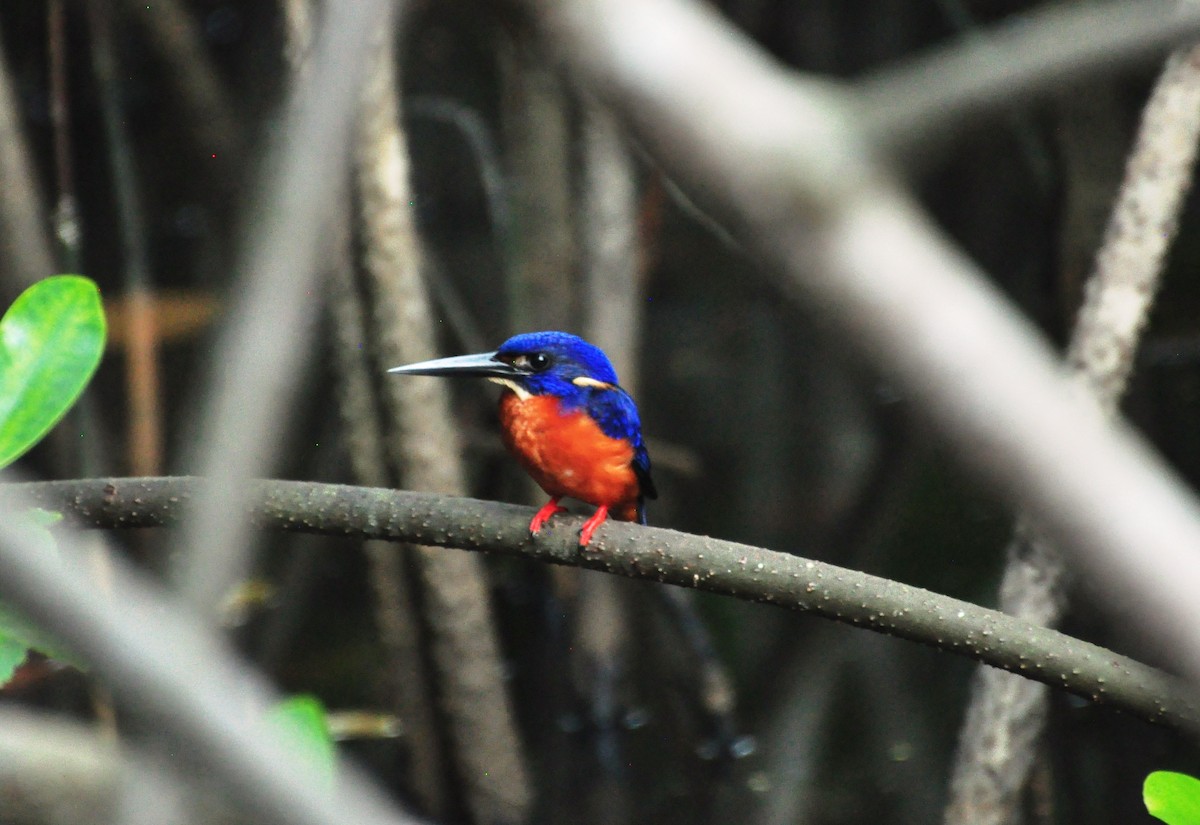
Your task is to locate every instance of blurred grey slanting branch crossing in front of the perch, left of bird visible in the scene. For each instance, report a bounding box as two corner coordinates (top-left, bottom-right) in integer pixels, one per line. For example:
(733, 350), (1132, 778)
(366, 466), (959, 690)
(175, 0), (392, 616)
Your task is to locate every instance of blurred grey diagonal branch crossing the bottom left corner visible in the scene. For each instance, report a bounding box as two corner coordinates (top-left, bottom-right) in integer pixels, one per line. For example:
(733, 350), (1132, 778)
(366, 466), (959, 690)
(0, 486), (427, 825)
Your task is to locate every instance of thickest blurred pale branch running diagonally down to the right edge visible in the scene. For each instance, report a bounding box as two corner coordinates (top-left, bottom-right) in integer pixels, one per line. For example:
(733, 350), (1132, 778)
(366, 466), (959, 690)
(526, 0), (1200, 680)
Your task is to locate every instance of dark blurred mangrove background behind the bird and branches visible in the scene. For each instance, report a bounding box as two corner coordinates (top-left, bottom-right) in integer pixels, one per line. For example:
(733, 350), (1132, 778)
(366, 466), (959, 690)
(0, 0), (1200, 825)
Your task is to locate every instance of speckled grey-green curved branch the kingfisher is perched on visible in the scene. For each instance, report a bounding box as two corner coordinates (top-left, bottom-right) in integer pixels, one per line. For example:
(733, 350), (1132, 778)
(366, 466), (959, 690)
(11, 477), (1200, 729)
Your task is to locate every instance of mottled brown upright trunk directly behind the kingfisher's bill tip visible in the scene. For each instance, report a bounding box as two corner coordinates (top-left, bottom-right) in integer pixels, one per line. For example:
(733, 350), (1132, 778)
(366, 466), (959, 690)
(355, 30), (532, 823)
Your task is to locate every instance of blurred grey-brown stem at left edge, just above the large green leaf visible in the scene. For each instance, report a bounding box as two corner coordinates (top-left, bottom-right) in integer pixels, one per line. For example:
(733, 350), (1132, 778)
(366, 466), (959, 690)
(0, 26), (55, 294)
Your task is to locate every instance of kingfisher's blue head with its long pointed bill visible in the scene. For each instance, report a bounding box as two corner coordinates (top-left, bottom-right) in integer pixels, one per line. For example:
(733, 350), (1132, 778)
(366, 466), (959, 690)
(388, 332), (617, 405)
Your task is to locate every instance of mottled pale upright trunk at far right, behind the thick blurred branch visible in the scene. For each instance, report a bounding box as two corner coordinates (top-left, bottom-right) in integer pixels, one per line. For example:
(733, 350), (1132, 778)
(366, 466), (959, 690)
(946, 40), (1200, 825)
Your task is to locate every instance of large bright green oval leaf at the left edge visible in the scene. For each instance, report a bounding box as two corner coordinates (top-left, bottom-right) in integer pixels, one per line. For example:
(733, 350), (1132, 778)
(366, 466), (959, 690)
(0, 275), (106, 466)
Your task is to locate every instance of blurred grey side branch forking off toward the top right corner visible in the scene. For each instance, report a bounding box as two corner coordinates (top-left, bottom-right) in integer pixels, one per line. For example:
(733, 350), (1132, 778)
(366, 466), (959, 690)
(857, 0), (1200, 156)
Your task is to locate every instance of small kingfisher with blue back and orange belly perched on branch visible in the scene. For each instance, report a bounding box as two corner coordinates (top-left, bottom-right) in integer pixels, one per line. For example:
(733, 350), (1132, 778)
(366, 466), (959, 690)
(388, 331), (658, 547)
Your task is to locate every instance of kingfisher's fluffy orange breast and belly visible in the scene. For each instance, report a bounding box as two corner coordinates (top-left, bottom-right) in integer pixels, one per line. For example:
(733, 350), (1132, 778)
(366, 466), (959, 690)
(500, 391), (638, 522)
